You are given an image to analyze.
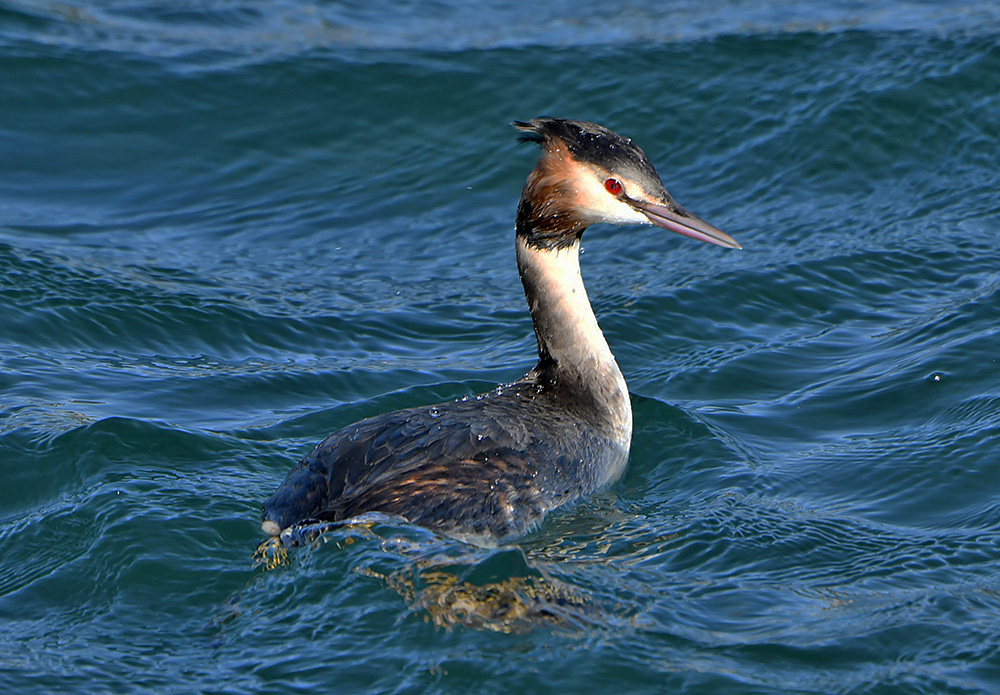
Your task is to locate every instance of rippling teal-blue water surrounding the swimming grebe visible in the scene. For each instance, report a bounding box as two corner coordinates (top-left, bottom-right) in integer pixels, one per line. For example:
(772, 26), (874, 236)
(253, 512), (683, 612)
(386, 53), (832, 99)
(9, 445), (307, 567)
(0, 0), (1000, 694)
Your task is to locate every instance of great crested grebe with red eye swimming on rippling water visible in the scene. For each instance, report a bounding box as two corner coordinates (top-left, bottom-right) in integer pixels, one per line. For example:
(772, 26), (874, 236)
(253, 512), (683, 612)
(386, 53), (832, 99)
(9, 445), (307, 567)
(263, 118), (740, 544)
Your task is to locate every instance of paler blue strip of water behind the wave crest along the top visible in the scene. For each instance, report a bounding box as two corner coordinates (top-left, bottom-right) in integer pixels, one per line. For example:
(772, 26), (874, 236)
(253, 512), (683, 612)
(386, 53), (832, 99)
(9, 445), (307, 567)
(3, 1), (1000, 64)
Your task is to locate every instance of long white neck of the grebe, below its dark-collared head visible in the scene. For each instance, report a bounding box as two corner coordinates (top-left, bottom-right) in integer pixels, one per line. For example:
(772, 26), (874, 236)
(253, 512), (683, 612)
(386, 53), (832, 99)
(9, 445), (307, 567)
(516, 235), (632, 434)
